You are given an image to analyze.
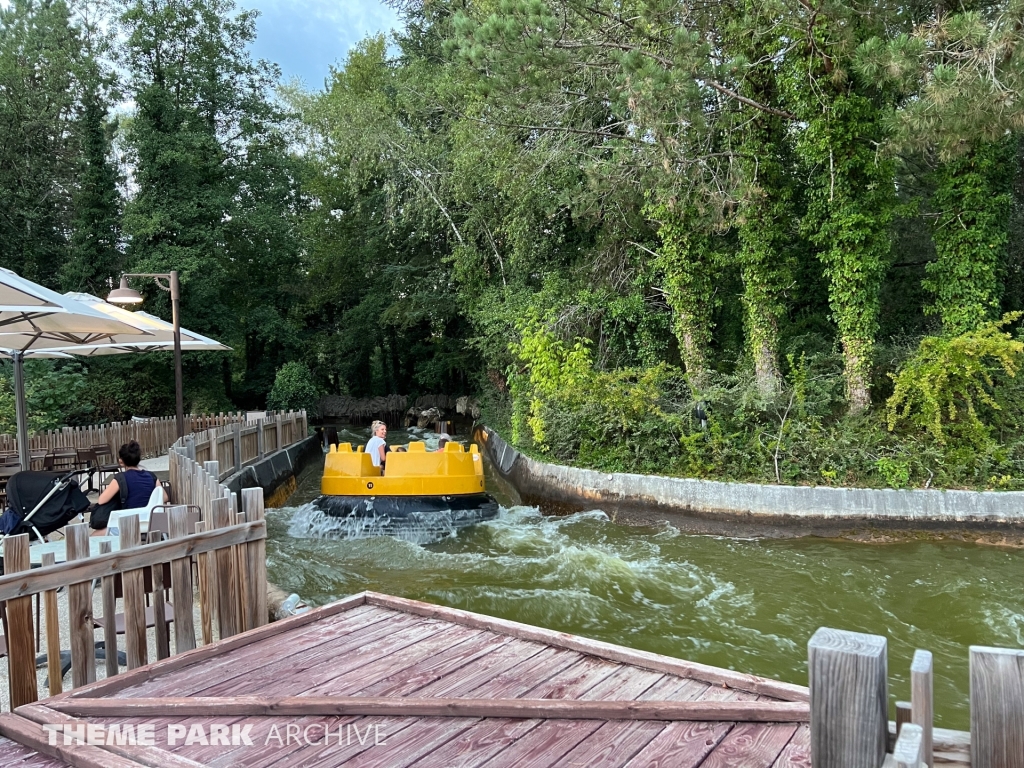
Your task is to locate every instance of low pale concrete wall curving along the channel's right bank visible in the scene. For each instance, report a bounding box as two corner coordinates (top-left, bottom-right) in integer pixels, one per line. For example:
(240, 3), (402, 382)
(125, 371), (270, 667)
(474, 426), (1024, 527)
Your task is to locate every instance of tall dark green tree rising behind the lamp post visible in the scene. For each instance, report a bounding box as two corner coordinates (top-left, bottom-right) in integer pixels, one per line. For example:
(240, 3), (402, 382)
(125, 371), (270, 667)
(120, 0), (301, 406)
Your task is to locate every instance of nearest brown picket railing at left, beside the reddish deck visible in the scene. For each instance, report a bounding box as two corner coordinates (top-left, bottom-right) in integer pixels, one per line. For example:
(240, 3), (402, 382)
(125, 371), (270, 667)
(0, 495), (268, 709)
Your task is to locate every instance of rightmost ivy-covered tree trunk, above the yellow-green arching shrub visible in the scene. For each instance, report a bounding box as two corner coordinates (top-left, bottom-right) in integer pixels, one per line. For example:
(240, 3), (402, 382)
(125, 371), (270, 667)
(925, 138), (1017, 336)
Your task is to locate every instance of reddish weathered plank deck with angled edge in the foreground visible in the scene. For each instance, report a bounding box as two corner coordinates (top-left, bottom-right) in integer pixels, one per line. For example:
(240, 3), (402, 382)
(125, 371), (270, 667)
(0, 593), (810, 768)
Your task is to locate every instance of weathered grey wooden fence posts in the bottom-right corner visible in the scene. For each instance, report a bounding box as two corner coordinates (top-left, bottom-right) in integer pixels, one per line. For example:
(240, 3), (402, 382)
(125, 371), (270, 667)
(807, 628), (1024, 768)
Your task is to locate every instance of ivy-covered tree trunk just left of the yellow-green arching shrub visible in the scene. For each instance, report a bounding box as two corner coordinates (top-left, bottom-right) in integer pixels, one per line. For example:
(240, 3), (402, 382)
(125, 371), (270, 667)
(799, 91), (897, 412)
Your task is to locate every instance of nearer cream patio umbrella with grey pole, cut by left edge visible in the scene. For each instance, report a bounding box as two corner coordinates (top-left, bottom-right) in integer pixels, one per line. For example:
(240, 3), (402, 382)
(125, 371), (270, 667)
(0, 268), (152, 469)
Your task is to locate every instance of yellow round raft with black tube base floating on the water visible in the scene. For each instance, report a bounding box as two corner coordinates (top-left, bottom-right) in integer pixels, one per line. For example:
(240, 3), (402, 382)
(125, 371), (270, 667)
(313, 442), (498, 537)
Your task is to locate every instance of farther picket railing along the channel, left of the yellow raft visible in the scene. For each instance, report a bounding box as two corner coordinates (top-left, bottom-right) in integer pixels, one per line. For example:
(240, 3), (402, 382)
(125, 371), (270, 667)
(168, 411), (309, 481)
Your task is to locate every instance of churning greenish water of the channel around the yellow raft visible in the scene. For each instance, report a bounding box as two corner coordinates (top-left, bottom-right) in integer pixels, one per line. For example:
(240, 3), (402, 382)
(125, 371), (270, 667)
(267, 432), (1024, 730)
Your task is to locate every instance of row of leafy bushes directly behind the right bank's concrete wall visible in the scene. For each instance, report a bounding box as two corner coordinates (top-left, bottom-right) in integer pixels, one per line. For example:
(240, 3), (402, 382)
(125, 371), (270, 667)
(505, 323), (1024, 489)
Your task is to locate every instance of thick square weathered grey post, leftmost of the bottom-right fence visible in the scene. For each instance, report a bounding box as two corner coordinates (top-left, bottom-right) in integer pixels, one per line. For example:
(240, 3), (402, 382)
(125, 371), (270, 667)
(807, 627), (889, 768)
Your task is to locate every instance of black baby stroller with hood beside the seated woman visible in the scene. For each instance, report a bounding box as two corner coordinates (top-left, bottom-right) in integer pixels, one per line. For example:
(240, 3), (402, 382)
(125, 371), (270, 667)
(0, 470), (89, 541)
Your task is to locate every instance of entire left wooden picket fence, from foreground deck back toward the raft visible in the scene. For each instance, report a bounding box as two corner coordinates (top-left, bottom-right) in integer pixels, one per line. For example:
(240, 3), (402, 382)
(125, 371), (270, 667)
(0, 411), (308, 709)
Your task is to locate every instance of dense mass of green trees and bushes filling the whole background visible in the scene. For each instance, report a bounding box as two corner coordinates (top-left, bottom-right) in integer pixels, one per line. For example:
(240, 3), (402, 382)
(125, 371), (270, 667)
(6, 0), (1024, 487)
